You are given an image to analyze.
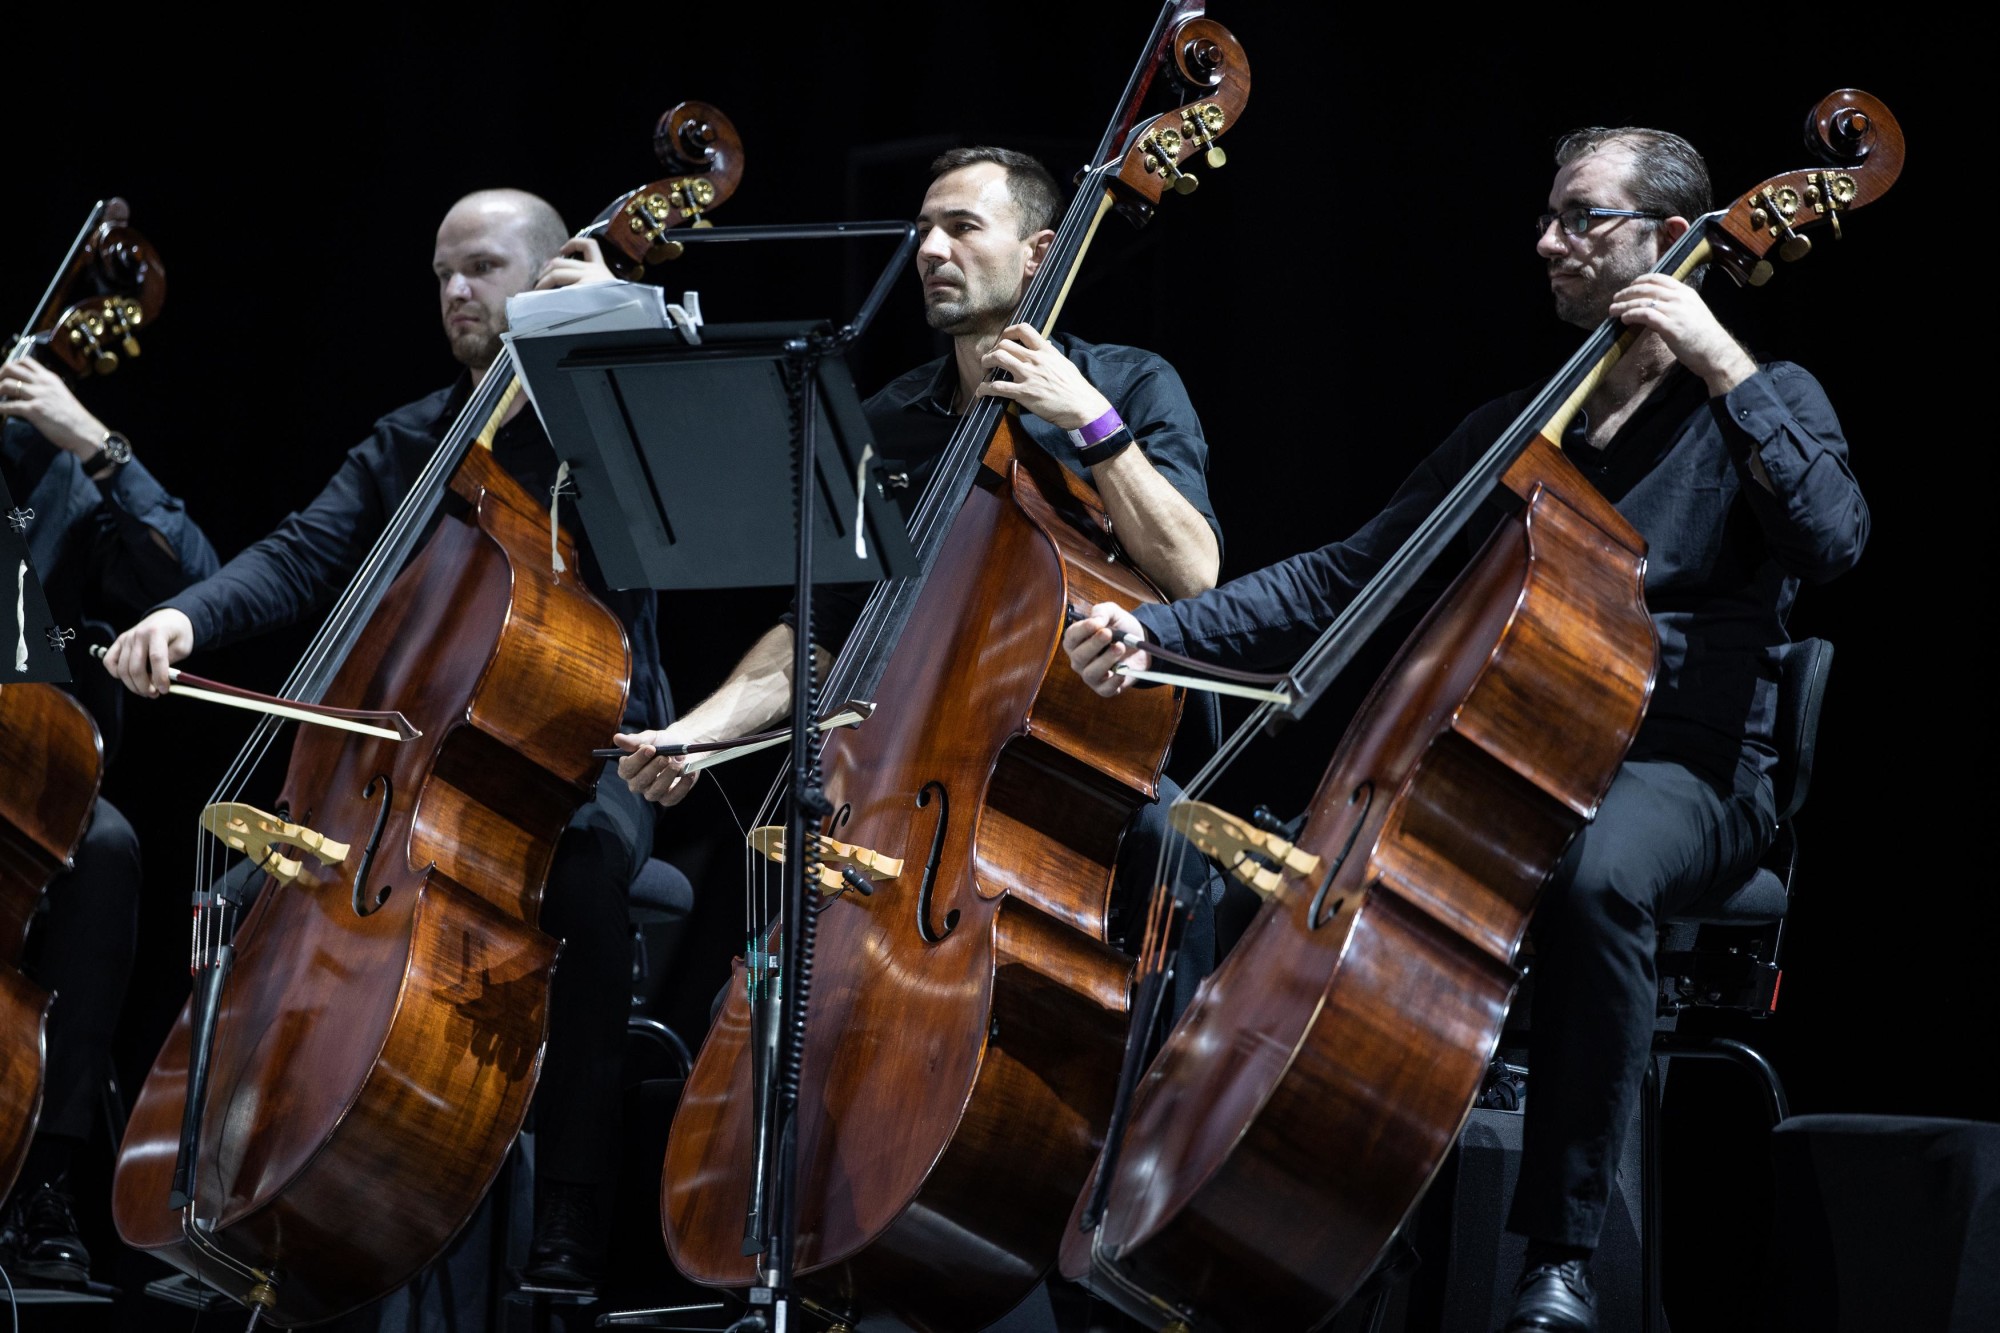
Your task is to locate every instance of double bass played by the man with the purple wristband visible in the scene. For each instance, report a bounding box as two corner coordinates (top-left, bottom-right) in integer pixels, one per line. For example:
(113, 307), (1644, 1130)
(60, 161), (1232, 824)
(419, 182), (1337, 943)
(662, 2), (1250, 1331)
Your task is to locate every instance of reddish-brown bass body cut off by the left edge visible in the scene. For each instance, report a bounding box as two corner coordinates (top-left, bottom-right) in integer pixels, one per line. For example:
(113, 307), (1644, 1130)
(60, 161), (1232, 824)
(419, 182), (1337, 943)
(0, 683), (104, 1197)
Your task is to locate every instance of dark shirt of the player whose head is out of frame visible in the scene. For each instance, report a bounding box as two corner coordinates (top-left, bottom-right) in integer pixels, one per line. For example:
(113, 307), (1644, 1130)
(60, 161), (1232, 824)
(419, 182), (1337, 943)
(0, 416), (216, 759)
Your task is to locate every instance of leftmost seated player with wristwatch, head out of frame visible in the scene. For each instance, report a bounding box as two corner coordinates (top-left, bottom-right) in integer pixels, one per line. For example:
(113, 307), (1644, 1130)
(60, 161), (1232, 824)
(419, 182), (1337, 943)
(0, 356), (216, 1283)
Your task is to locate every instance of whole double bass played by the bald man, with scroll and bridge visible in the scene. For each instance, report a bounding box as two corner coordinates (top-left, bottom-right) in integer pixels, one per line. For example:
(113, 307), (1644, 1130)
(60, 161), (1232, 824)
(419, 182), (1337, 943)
(112, 104), (742, 1327)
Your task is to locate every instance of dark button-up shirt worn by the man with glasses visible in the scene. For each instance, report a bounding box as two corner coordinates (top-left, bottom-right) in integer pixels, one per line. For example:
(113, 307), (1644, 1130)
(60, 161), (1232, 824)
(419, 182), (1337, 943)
(1136, 362), (1868, 795)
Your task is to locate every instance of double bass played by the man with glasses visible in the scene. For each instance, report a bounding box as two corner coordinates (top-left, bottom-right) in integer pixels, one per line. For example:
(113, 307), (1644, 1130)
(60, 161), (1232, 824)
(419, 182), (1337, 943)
(1062, 90), (1904, 1333)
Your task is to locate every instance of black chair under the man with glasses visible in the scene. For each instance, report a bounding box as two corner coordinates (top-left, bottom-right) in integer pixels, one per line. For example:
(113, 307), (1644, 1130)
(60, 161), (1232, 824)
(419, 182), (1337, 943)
(1640, 638), (1834, 1333)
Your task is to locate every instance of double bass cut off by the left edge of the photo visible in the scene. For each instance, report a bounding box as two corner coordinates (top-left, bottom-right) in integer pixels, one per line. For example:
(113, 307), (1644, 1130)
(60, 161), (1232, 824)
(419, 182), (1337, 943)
(0, 198), (166, 1199)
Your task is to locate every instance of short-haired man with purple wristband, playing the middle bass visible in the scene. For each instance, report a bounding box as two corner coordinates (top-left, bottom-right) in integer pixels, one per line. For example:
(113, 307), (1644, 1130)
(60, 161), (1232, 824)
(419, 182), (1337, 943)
(616, 146), (1222, 977)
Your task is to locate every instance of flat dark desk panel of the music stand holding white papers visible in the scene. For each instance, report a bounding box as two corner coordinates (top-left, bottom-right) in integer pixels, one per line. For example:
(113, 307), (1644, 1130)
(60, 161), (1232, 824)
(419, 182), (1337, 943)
(512, 322), (916, 588)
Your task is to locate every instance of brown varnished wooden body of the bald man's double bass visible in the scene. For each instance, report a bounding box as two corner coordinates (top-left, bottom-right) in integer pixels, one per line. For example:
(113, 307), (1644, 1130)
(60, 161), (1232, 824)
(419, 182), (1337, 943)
(114, 448), (630, 1325)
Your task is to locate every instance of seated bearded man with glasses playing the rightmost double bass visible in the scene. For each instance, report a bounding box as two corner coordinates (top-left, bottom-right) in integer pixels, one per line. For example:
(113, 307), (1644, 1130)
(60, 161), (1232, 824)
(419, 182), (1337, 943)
(1064, 128), (1868, 1331)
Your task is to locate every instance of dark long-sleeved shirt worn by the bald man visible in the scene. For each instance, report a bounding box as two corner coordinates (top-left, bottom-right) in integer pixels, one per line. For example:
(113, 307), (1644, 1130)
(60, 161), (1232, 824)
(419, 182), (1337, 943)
(164, 376), (674, 743)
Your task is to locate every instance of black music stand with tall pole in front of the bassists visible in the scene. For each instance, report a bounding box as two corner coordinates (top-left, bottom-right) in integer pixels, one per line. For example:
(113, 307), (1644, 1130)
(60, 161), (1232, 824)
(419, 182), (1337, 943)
(512, 222), (916, 1333)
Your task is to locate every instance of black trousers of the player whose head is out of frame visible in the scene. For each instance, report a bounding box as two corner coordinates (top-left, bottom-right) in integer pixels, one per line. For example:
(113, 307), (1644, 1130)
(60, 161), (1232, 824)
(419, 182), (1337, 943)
(22, 799), (140, 1139)
